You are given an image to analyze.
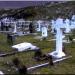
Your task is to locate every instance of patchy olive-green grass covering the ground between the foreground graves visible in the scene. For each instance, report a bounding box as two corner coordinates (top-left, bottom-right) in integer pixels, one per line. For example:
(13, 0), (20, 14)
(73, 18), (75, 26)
(0, 33), (75, 74)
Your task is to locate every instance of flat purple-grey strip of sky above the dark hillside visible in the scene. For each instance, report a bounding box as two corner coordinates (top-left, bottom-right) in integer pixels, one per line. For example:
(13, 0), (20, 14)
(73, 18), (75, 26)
(0, 1), (48, 8)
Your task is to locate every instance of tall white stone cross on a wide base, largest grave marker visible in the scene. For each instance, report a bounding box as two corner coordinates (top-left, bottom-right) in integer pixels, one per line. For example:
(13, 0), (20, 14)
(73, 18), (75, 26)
(49, 18), (65, 58)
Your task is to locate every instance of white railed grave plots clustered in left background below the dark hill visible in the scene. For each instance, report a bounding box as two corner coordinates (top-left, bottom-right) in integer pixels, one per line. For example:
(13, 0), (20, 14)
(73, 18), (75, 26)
(0, 17), (33, 33)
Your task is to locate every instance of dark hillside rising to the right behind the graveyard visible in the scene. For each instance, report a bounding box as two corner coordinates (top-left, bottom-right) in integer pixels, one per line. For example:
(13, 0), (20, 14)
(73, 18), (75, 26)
(0, 1), (75, 20)
